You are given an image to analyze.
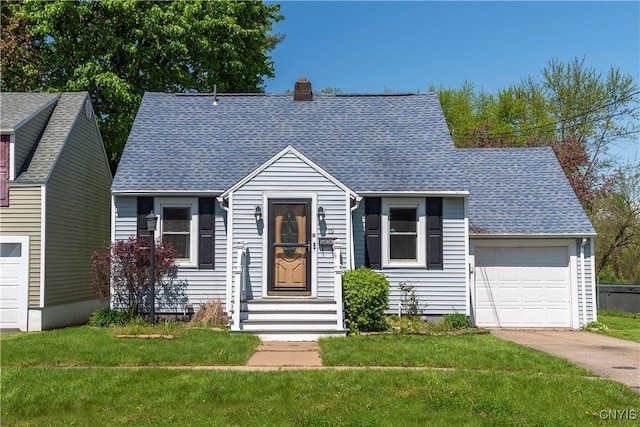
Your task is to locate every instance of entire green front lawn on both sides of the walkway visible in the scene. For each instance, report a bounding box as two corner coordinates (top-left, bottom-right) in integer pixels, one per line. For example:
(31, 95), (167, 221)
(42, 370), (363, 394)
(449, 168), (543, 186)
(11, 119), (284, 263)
(0, 326), (640, 426)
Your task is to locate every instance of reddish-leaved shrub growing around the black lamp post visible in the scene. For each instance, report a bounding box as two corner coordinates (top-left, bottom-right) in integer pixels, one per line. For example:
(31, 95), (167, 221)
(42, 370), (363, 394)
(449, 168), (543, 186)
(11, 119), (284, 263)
(91, 237), (180, 319)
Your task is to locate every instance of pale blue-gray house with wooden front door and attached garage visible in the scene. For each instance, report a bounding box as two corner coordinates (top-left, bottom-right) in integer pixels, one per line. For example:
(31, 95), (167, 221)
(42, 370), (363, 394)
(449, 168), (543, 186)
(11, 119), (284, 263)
(112, 79), (596, 339)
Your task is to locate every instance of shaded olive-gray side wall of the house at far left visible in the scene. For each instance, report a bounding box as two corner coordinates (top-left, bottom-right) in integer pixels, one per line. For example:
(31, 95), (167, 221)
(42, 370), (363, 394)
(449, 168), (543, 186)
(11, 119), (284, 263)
(44, 109), (111, 306)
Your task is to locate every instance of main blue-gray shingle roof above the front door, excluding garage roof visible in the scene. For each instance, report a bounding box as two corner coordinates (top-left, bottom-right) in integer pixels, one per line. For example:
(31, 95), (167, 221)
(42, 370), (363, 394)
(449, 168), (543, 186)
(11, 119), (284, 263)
(112, 93), (463, 192)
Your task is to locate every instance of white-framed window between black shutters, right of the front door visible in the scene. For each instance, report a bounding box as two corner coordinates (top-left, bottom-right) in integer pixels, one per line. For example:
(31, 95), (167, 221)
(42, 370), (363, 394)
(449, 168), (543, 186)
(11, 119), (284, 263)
(382, 198), (426, 267)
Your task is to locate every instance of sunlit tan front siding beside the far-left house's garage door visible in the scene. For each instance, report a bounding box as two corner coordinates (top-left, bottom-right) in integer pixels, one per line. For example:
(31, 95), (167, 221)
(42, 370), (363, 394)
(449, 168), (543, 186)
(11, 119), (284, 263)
(0, 186), (42, 307)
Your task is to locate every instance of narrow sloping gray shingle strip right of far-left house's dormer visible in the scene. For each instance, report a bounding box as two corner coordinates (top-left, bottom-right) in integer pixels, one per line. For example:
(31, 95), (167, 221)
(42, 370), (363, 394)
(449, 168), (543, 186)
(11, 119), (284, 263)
(16, 92), (88, 183)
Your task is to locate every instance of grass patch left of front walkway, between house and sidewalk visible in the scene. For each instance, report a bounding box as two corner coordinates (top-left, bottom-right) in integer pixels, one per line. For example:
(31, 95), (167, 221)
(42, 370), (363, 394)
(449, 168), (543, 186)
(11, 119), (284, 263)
(0, 326), (260, 368)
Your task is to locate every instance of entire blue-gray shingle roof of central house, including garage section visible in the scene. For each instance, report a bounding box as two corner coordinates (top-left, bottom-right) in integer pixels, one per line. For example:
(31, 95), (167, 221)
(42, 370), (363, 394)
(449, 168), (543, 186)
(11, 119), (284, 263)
(112, 93), (594, 235)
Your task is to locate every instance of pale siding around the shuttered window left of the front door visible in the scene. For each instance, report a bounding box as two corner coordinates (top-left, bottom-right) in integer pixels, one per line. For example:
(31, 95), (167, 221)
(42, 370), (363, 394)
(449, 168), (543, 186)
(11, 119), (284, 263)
(114, 196), (227, 310)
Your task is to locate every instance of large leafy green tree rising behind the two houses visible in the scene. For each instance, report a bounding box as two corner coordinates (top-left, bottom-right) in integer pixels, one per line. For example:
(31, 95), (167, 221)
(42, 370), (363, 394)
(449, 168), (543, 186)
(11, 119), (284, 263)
(0, 0), (282, 170)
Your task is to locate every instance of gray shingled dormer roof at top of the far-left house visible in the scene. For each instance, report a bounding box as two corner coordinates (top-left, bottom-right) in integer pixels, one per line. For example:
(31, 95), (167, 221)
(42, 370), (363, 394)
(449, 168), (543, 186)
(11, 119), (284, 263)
(0, 92), (60, 131)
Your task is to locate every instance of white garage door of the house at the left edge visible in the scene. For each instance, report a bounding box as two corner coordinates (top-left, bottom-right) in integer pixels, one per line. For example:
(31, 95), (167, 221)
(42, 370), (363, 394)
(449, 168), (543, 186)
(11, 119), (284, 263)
(0, 238), (29, 329)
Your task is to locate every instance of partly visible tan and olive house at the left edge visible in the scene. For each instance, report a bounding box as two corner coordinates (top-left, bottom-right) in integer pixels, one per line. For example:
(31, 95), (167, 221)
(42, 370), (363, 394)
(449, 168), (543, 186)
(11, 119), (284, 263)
(0, 92), (111, 331)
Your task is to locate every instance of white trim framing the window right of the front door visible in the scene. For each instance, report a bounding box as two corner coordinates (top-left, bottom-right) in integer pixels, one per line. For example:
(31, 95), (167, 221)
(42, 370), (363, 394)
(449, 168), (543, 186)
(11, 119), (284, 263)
(380, 197), (427, 268)
